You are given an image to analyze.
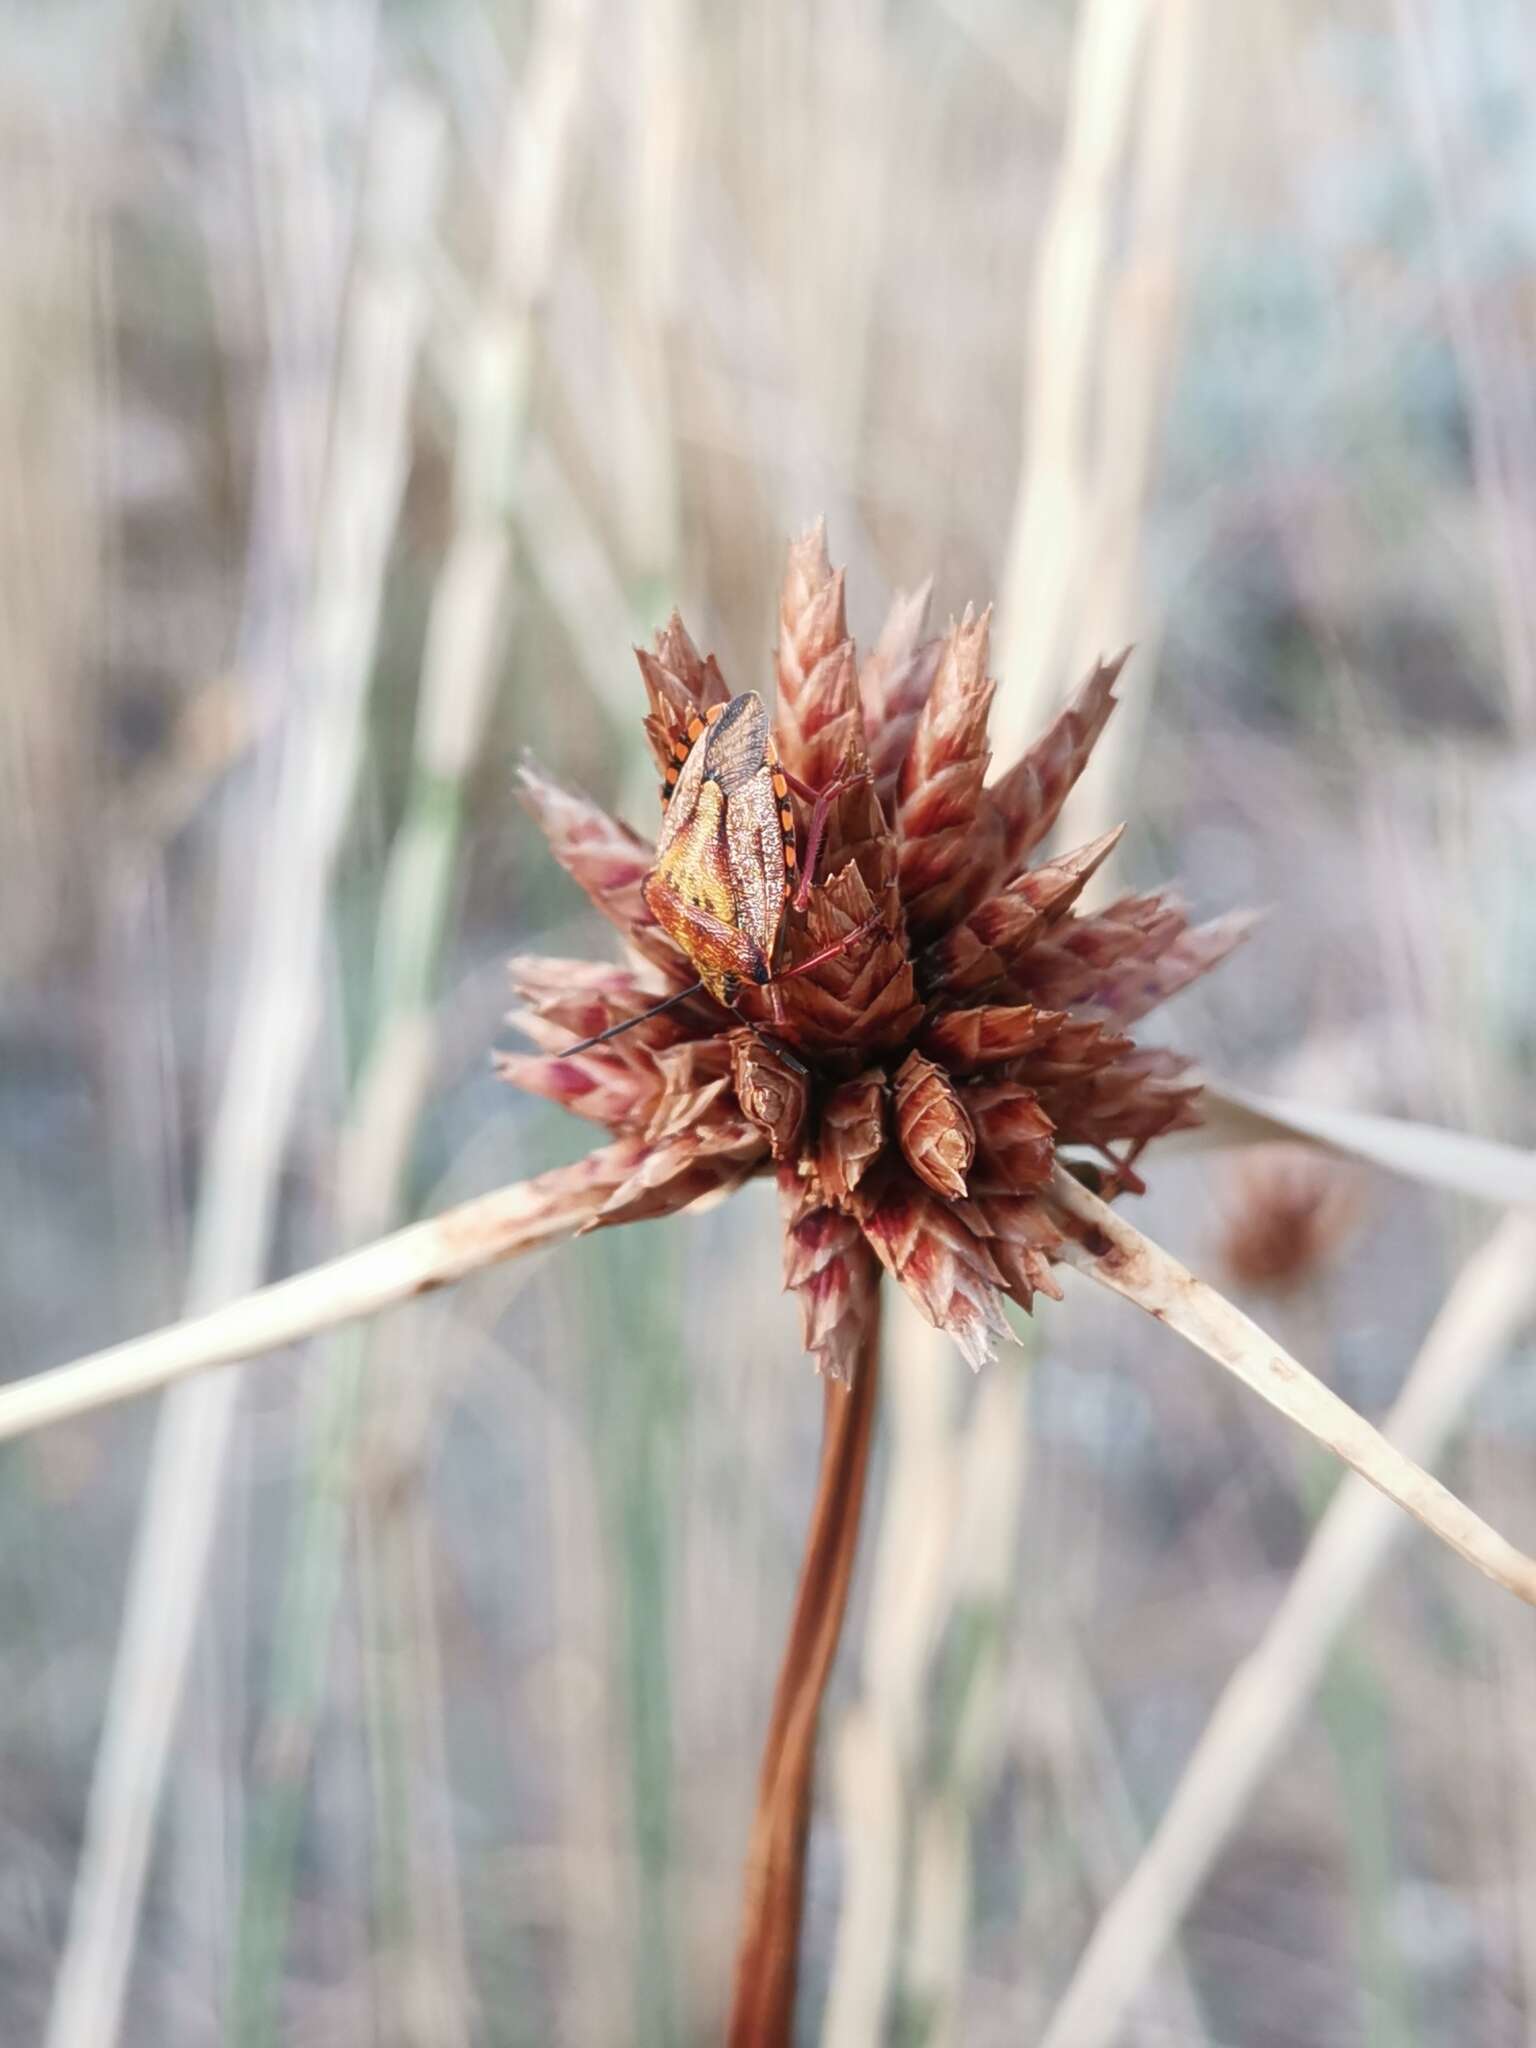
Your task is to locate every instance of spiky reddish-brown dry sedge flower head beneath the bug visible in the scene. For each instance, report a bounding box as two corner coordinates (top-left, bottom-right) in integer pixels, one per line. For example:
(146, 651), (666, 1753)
(502, 526), (1247, 1378)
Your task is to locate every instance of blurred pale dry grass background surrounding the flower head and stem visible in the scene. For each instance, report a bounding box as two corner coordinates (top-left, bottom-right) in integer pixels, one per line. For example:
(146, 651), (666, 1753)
(0, 0), (1536, 2048)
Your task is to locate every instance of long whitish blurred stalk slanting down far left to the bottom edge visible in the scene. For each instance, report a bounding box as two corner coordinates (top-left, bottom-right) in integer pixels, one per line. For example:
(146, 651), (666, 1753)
(47, 80), (442, 2048)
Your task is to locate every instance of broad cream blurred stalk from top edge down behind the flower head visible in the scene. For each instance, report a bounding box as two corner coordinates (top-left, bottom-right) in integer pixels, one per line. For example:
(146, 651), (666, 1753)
(995, 0), (1217, 864)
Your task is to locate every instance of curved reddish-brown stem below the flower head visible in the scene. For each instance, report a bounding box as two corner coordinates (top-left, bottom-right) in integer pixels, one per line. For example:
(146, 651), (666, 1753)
(727, 1296), (881, 2048)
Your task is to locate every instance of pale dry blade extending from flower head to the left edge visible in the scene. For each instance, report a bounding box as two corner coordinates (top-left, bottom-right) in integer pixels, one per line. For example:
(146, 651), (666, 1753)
(0, 1145), (635, 1442)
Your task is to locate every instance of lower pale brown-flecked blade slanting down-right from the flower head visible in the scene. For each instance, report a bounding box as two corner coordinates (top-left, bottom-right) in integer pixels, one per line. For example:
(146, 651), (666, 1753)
(1051, 1167), (1536, 1606)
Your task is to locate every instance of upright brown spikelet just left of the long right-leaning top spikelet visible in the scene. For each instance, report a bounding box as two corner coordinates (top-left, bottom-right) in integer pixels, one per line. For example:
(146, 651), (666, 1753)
(895, 606), (997, 944)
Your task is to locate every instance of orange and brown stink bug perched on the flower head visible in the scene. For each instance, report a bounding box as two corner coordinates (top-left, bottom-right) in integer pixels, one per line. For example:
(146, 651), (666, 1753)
(567, 690), (879, 1053)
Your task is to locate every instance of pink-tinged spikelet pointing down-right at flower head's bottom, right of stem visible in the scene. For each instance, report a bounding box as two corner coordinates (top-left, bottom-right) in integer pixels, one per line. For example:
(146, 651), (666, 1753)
(852, 1159), (1012, 1370)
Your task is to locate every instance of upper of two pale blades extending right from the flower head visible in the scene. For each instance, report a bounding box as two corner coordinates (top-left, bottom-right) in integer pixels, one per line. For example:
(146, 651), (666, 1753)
(1163, 1079), (1536, 1204)
